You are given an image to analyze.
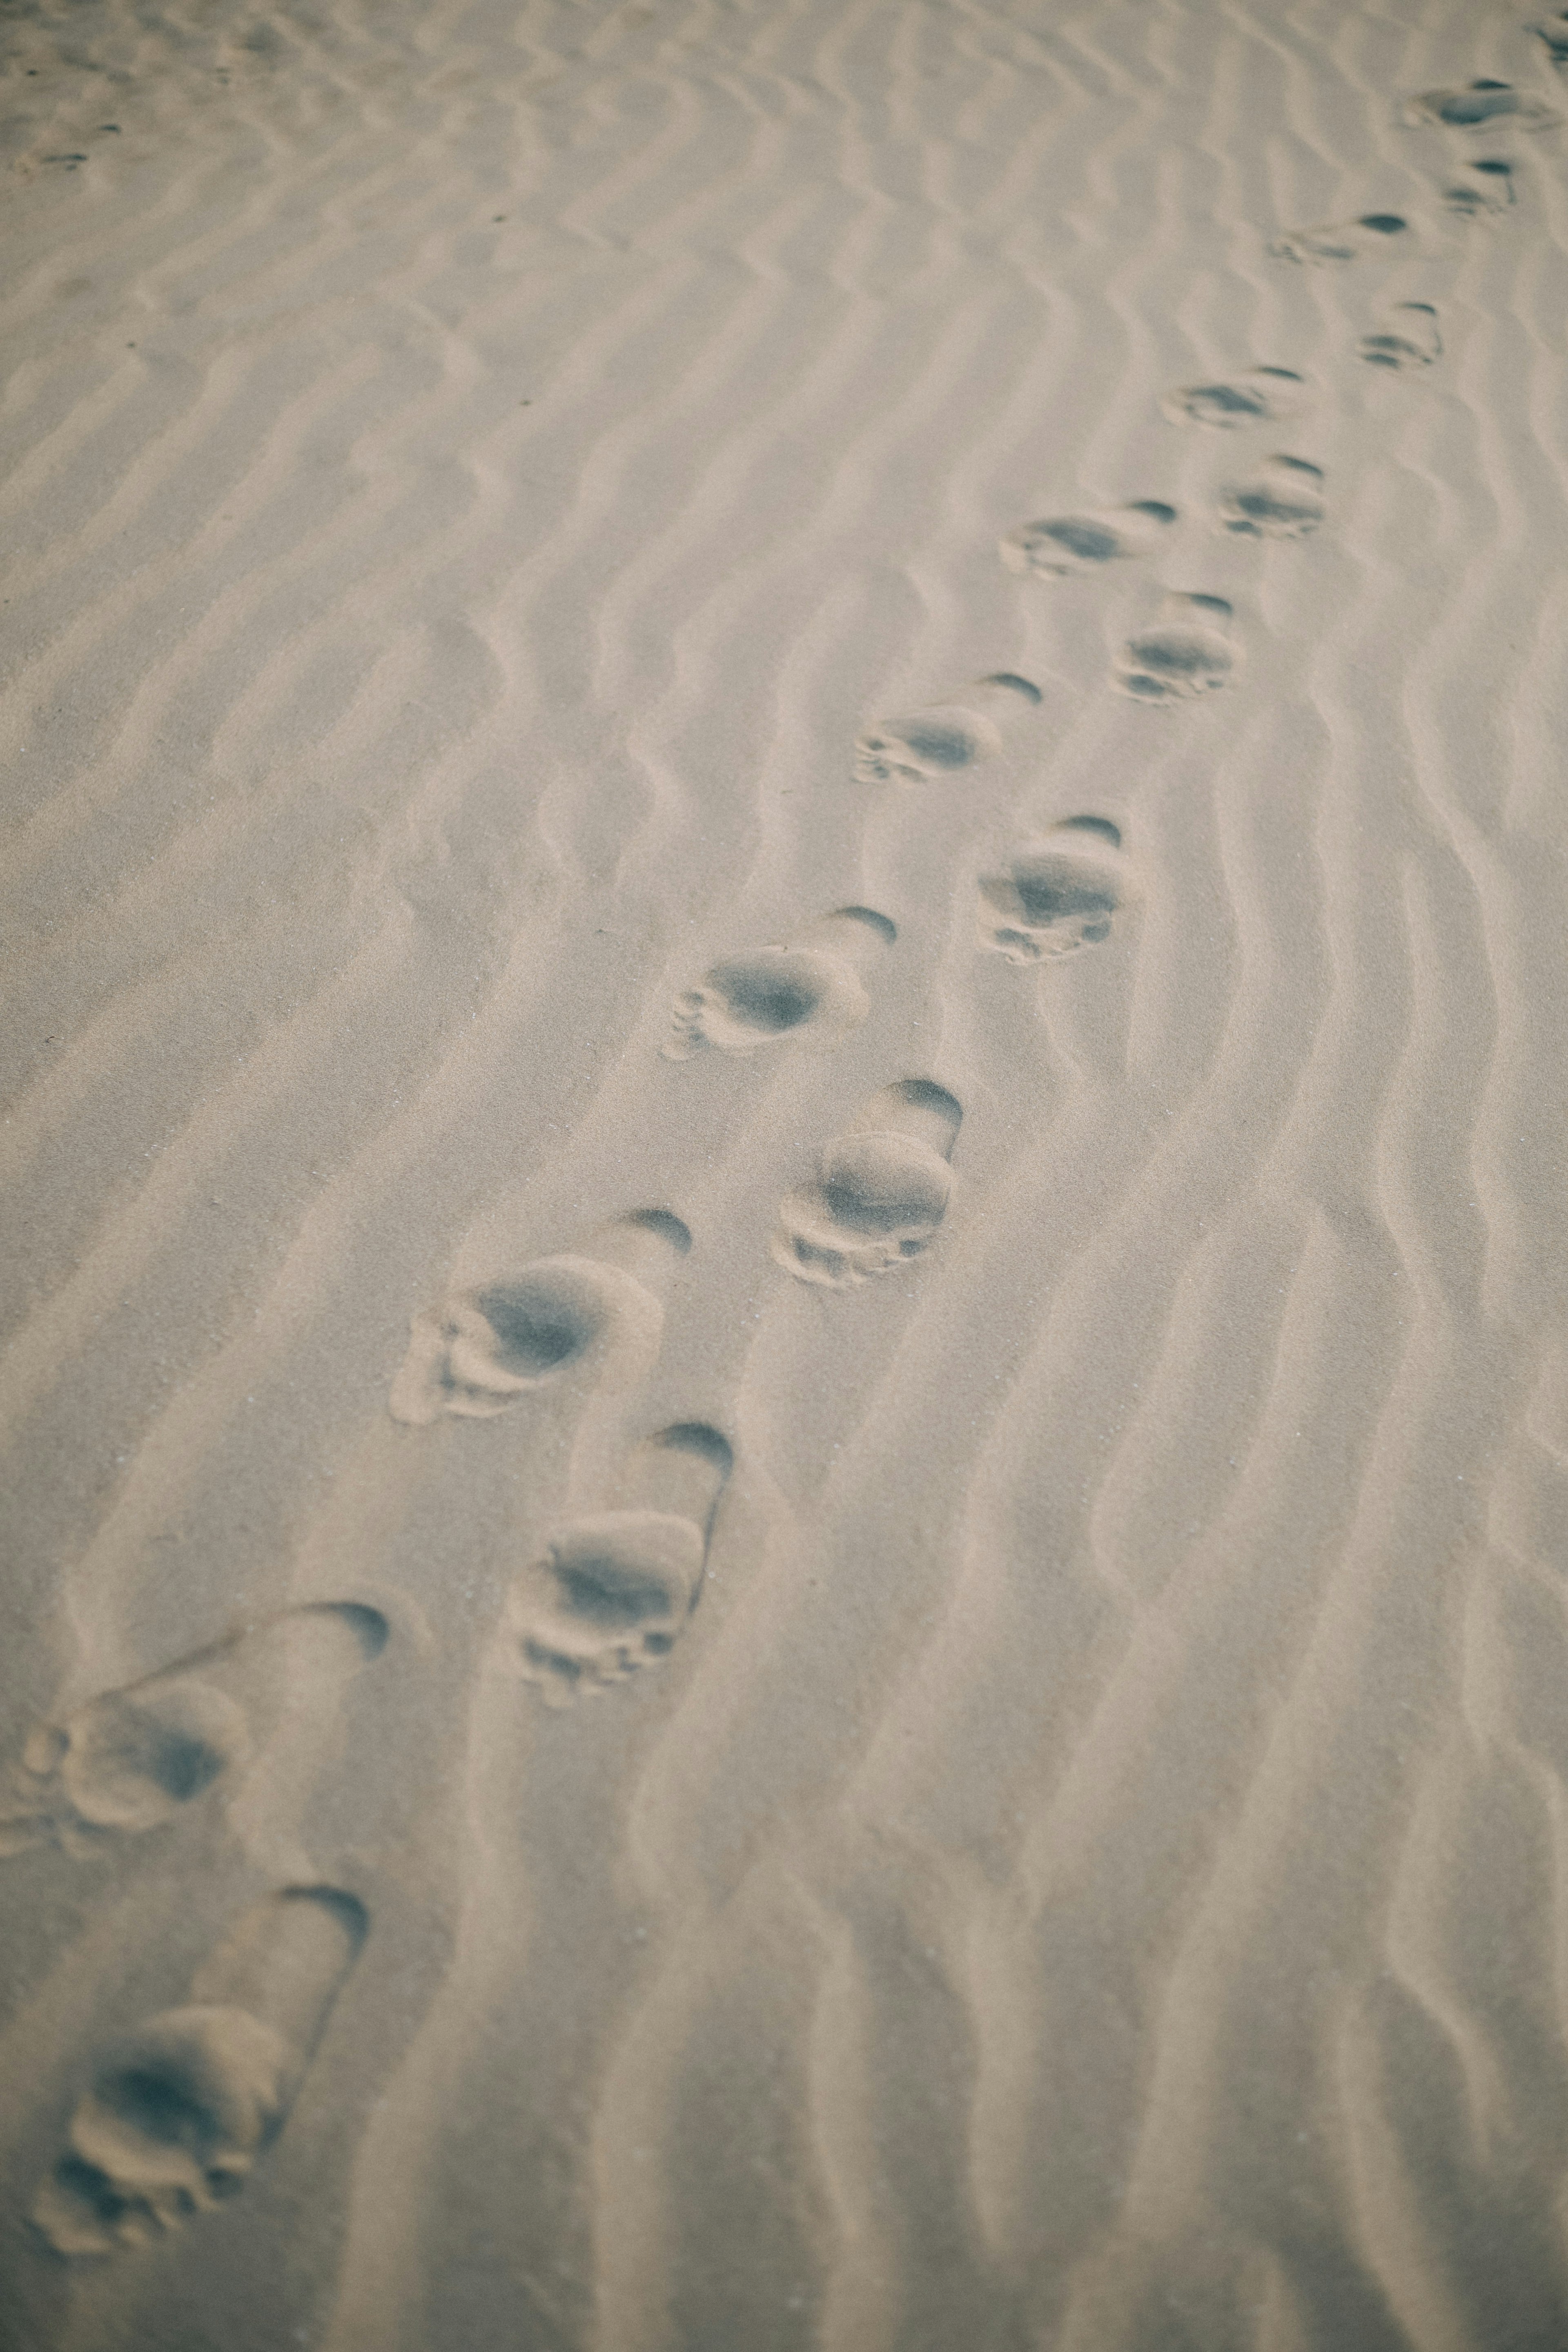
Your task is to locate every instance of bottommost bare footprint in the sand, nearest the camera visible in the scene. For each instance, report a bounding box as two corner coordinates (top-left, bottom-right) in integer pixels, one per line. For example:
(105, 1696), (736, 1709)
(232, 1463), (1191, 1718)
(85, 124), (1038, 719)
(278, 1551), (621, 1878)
(33, 1886), (367, 2256)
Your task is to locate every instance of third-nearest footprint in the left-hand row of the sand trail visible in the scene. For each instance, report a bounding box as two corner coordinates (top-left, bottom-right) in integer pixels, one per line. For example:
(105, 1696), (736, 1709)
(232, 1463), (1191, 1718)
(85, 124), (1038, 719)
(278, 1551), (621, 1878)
(663, 906), (898, 1061)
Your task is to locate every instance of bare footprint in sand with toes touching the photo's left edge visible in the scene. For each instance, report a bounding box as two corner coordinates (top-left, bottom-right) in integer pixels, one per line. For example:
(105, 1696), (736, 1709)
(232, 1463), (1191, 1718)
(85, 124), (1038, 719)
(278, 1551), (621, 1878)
(0, 1602), (388, 1860)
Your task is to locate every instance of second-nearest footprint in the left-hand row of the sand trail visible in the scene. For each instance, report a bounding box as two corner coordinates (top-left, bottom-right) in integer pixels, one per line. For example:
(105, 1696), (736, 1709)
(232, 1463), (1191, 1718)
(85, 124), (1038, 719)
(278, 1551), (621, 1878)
(388, 1209), (691, 1428)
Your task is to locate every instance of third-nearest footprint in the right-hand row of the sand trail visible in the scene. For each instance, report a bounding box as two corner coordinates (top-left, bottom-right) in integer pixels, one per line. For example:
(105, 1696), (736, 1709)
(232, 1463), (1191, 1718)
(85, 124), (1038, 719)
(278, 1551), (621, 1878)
(771, 1077), (964, 1289)
